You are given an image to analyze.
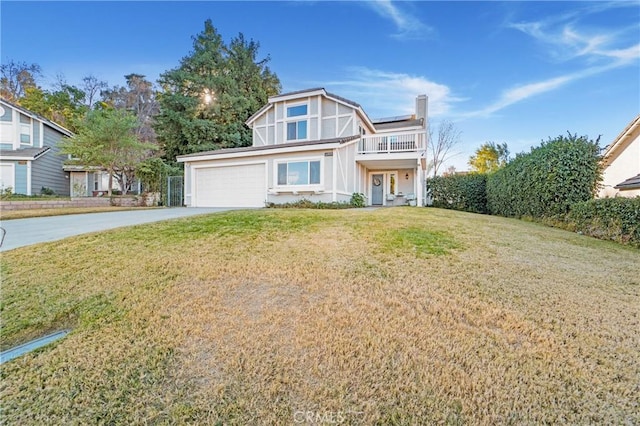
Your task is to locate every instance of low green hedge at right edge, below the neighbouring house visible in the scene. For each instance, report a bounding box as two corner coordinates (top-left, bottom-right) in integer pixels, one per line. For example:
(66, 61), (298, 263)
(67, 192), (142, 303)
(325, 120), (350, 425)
(565, 197), (640, 247)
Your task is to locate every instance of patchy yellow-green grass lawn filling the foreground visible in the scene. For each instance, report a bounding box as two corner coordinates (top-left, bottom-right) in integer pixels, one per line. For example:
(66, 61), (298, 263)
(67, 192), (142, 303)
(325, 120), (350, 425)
(0, 208), (640, 425)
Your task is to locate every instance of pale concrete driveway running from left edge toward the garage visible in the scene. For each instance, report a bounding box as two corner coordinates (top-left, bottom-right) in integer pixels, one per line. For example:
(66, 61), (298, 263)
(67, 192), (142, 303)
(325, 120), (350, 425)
(0, 207), (234, 251)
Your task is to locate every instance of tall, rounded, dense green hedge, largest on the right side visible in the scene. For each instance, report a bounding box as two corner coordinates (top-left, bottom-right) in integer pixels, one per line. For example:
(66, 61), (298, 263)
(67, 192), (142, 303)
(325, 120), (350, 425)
(487, 134), (601, 218)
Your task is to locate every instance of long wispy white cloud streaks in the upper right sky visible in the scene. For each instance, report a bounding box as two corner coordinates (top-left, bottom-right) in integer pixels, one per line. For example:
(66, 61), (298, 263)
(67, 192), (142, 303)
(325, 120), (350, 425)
(462, 3), (640, 117)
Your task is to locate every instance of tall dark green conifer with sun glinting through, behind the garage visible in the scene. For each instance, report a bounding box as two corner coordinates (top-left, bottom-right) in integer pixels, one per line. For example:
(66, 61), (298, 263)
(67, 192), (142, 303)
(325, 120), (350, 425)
(154, 20), (280, 162)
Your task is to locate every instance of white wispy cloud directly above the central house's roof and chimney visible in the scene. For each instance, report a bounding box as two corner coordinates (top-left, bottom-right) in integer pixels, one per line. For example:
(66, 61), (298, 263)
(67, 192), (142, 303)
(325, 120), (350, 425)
(320, 67), (462, 118)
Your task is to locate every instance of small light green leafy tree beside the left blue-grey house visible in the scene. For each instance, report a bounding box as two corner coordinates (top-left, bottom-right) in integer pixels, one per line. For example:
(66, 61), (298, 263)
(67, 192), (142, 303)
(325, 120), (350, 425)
(60, 109), (156, 195)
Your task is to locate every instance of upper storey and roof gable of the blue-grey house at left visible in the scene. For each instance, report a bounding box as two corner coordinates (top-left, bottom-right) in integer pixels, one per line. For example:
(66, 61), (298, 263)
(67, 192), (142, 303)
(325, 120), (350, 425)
(0, 99), (71, 151)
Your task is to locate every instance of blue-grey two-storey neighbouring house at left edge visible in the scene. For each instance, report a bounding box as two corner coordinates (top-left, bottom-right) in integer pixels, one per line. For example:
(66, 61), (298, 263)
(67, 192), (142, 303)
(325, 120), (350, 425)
(0, 98), (71, 195)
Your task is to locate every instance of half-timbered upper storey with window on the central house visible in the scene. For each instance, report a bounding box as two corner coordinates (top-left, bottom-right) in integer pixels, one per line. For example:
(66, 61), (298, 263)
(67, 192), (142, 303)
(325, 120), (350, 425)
(246, 88), (376, 146)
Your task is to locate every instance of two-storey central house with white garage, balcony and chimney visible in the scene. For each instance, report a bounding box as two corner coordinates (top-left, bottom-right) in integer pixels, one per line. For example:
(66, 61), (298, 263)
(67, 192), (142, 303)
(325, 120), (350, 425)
(177, 88), (427, 207)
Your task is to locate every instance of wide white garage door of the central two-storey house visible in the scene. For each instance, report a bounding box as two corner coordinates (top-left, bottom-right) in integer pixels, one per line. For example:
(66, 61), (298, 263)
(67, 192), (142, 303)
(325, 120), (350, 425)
(194, 164), (266, 207)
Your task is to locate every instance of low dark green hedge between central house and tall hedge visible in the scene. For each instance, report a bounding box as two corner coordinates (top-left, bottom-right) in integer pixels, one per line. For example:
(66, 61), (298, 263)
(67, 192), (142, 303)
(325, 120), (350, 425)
(427, 173), (487, 213)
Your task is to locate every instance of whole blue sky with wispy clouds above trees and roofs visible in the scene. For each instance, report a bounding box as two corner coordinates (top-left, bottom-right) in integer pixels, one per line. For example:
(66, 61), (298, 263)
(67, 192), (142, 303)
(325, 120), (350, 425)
(0, 0), (640, 170)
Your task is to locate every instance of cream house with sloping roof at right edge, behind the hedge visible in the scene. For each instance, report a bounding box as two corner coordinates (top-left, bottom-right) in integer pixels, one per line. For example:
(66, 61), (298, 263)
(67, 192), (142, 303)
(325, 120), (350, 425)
(598, 115), (640, 198)
